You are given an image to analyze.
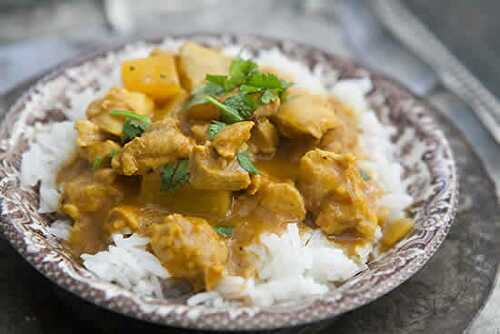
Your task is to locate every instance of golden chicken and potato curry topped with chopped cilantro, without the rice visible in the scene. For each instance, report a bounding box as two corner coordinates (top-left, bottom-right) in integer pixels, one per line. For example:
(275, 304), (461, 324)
(57, 42), (413, 291)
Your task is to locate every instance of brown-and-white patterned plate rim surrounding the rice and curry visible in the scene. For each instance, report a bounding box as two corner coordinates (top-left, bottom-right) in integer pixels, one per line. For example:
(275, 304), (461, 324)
(0, 34), (458, 330)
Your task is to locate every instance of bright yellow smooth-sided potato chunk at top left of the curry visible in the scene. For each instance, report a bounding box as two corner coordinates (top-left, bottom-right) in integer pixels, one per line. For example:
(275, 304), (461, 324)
(121, 51), (181, 100)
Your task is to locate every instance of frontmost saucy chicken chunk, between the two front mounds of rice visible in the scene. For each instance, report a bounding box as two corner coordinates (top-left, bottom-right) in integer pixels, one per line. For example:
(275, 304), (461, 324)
(147, 214), (228, 291)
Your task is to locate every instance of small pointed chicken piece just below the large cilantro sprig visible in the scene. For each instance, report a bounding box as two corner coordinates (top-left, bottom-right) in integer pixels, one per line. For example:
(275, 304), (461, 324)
(212, 121), (254, 159)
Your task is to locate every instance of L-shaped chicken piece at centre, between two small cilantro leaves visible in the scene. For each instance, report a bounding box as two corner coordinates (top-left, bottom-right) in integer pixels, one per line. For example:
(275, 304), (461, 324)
(189, 145), (250, 191)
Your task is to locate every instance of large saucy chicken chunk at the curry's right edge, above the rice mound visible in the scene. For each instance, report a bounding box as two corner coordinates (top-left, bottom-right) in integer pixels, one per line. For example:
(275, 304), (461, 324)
(298, 149), (378, 240)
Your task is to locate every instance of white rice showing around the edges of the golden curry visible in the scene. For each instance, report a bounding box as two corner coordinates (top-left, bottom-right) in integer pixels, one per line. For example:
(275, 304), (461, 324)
(21, 43), (412, 307)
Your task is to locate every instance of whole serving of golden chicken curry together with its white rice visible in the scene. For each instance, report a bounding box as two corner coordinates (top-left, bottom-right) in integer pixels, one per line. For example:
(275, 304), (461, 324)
(22, 42), (414, 306)
